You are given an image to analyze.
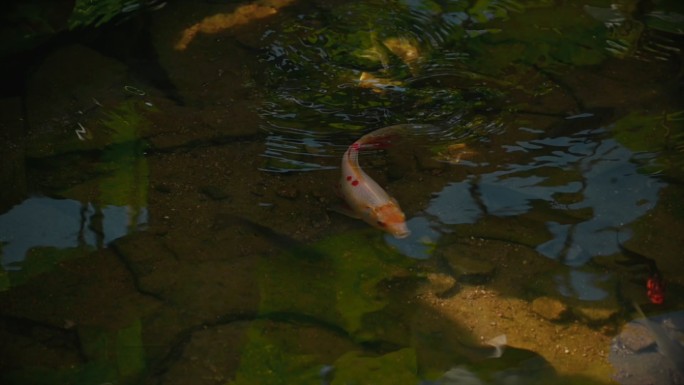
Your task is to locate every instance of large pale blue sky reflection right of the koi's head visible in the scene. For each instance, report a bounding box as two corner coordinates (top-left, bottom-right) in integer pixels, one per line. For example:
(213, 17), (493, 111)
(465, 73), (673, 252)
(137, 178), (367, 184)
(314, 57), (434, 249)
(386, 126), (665, 300)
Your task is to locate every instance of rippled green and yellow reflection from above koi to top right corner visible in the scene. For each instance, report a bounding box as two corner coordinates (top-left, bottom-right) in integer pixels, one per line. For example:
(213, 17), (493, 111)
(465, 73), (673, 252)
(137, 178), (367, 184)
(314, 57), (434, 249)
(260, 0), (682, 172)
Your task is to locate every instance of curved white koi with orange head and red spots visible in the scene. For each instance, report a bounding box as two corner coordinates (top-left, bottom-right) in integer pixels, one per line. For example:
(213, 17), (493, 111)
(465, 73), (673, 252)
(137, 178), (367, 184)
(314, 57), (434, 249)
(339, 124), (415, 238)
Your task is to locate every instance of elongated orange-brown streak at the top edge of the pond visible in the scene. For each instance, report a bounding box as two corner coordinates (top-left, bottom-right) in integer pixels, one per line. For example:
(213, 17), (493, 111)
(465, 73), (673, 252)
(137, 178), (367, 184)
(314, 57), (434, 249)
(175, 0), (294, 51)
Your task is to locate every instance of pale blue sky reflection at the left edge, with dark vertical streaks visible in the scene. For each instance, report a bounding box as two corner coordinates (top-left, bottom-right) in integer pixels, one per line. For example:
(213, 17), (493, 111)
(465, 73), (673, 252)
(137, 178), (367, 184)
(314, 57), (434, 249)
(0, 197), (147, 270)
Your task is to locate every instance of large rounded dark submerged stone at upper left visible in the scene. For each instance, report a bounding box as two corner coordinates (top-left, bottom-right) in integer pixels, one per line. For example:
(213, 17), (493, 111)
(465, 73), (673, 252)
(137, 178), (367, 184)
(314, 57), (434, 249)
(26, 44), (127, 157)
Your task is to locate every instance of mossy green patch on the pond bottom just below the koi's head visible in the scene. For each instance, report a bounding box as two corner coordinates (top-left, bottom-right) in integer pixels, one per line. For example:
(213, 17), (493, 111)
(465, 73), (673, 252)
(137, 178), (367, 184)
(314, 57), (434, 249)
(260, 231), (413, 335)
